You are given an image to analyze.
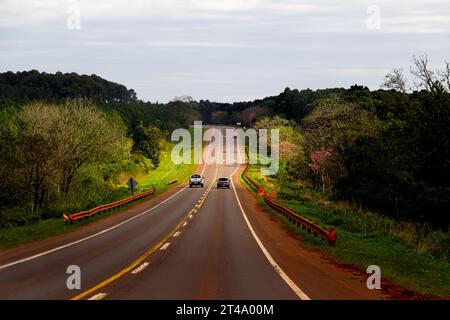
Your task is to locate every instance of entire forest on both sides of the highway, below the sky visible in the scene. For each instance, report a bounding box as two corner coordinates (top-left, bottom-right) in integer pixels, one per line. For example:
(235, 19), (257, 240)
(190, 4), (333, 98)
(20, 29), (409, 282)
(0, 56), (450, 231)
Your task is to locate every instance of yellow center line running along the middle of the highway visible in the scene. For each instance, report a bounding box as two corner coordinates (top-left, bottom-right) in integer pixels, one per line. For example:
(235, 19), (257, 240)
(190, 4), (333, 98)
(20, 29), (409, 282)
(70, 165), (219, 300)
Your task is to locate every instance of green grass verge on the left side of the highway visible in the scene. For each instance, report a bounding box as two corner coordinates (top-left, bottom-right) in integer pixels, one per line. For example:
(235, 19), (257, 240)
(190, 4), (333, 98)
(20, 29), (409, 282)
(0, 143), (197, 250)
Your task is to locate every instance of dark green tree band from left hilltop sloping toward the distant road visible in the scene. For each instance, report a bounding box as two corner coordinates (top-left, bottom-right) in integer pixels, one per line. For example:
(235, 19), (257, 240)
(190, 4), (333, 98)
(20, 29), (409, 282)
(0, 70), (199, 134)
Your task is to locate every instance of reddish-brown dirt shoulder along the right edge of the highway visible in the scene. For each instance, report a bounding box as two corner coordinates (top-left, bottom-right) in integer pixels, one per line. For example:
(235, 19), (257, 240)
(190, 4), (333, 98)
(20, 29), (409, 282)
(233, 167), (393, 300)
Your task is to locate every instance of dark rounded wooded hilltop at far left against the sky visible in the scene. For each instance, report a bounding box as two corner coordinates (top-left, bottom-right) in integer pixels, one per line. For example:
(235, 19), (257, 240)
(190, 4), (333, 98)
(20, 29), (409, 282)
(0, 70), (136, 107)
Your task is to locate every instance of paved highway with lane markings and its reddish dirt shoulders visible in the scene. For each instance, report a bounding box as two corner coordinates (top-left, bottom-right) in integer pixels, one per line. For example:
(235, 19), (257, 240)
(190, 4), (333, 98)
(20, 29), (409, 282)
(0, 127), (387, 300)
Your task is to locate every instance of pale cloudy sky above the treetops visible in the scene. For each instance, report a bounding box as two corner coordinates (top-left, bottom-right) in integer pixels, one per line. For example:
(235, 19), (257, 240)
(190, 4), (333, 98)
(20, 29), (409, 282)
(0, 0), (450, 102)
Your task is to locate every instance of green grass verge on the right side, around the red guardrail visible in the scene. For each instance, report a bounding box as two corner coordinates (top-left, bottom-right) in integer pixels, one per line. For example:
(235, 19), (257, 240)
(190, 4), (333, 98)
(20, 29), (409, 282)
(244, 166), (450, 297)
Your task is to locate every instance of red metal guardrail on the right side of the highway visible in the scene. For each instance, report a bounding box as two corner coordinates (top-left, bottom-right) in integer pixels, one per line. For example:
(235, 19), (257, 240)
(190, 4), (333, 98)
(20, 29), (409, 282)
(242, 163), (337, 246)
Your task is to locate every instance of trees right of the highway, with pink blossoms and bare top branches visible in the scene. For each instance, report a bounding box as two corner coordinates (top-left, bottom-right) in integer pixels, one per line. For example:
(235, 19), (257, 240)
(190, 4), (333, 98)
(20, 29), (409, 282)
(246, 56), (450, 230)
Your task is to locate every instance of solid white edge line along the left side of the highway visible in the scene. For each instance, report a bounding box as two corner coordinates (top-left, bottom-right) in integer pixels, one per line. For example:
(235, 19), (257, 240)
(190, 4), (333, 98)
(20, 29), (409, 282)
(0, 152), (210, 271)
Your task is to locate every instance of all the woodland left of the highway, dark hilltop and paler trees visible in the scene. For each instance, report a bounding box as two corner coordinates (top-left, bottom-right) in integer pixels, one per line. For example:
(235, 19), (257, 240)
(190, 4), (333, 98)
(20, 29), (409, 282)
(0, 70), (199, 227)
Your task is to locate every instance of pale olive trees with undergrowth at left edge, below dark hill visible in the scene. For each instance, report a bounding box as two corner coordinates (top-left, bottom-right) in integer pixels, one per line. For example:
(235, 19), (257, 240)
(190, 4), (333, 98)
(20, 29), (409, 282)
(0, 100), (130, 225)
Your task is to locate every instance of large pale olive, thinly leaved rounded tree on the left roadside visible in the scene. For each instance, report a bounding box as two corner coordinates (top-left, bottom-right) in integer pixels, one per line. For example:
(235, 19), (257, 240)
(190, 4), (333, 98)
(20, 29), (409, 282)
(15, 100), (124, 210)
